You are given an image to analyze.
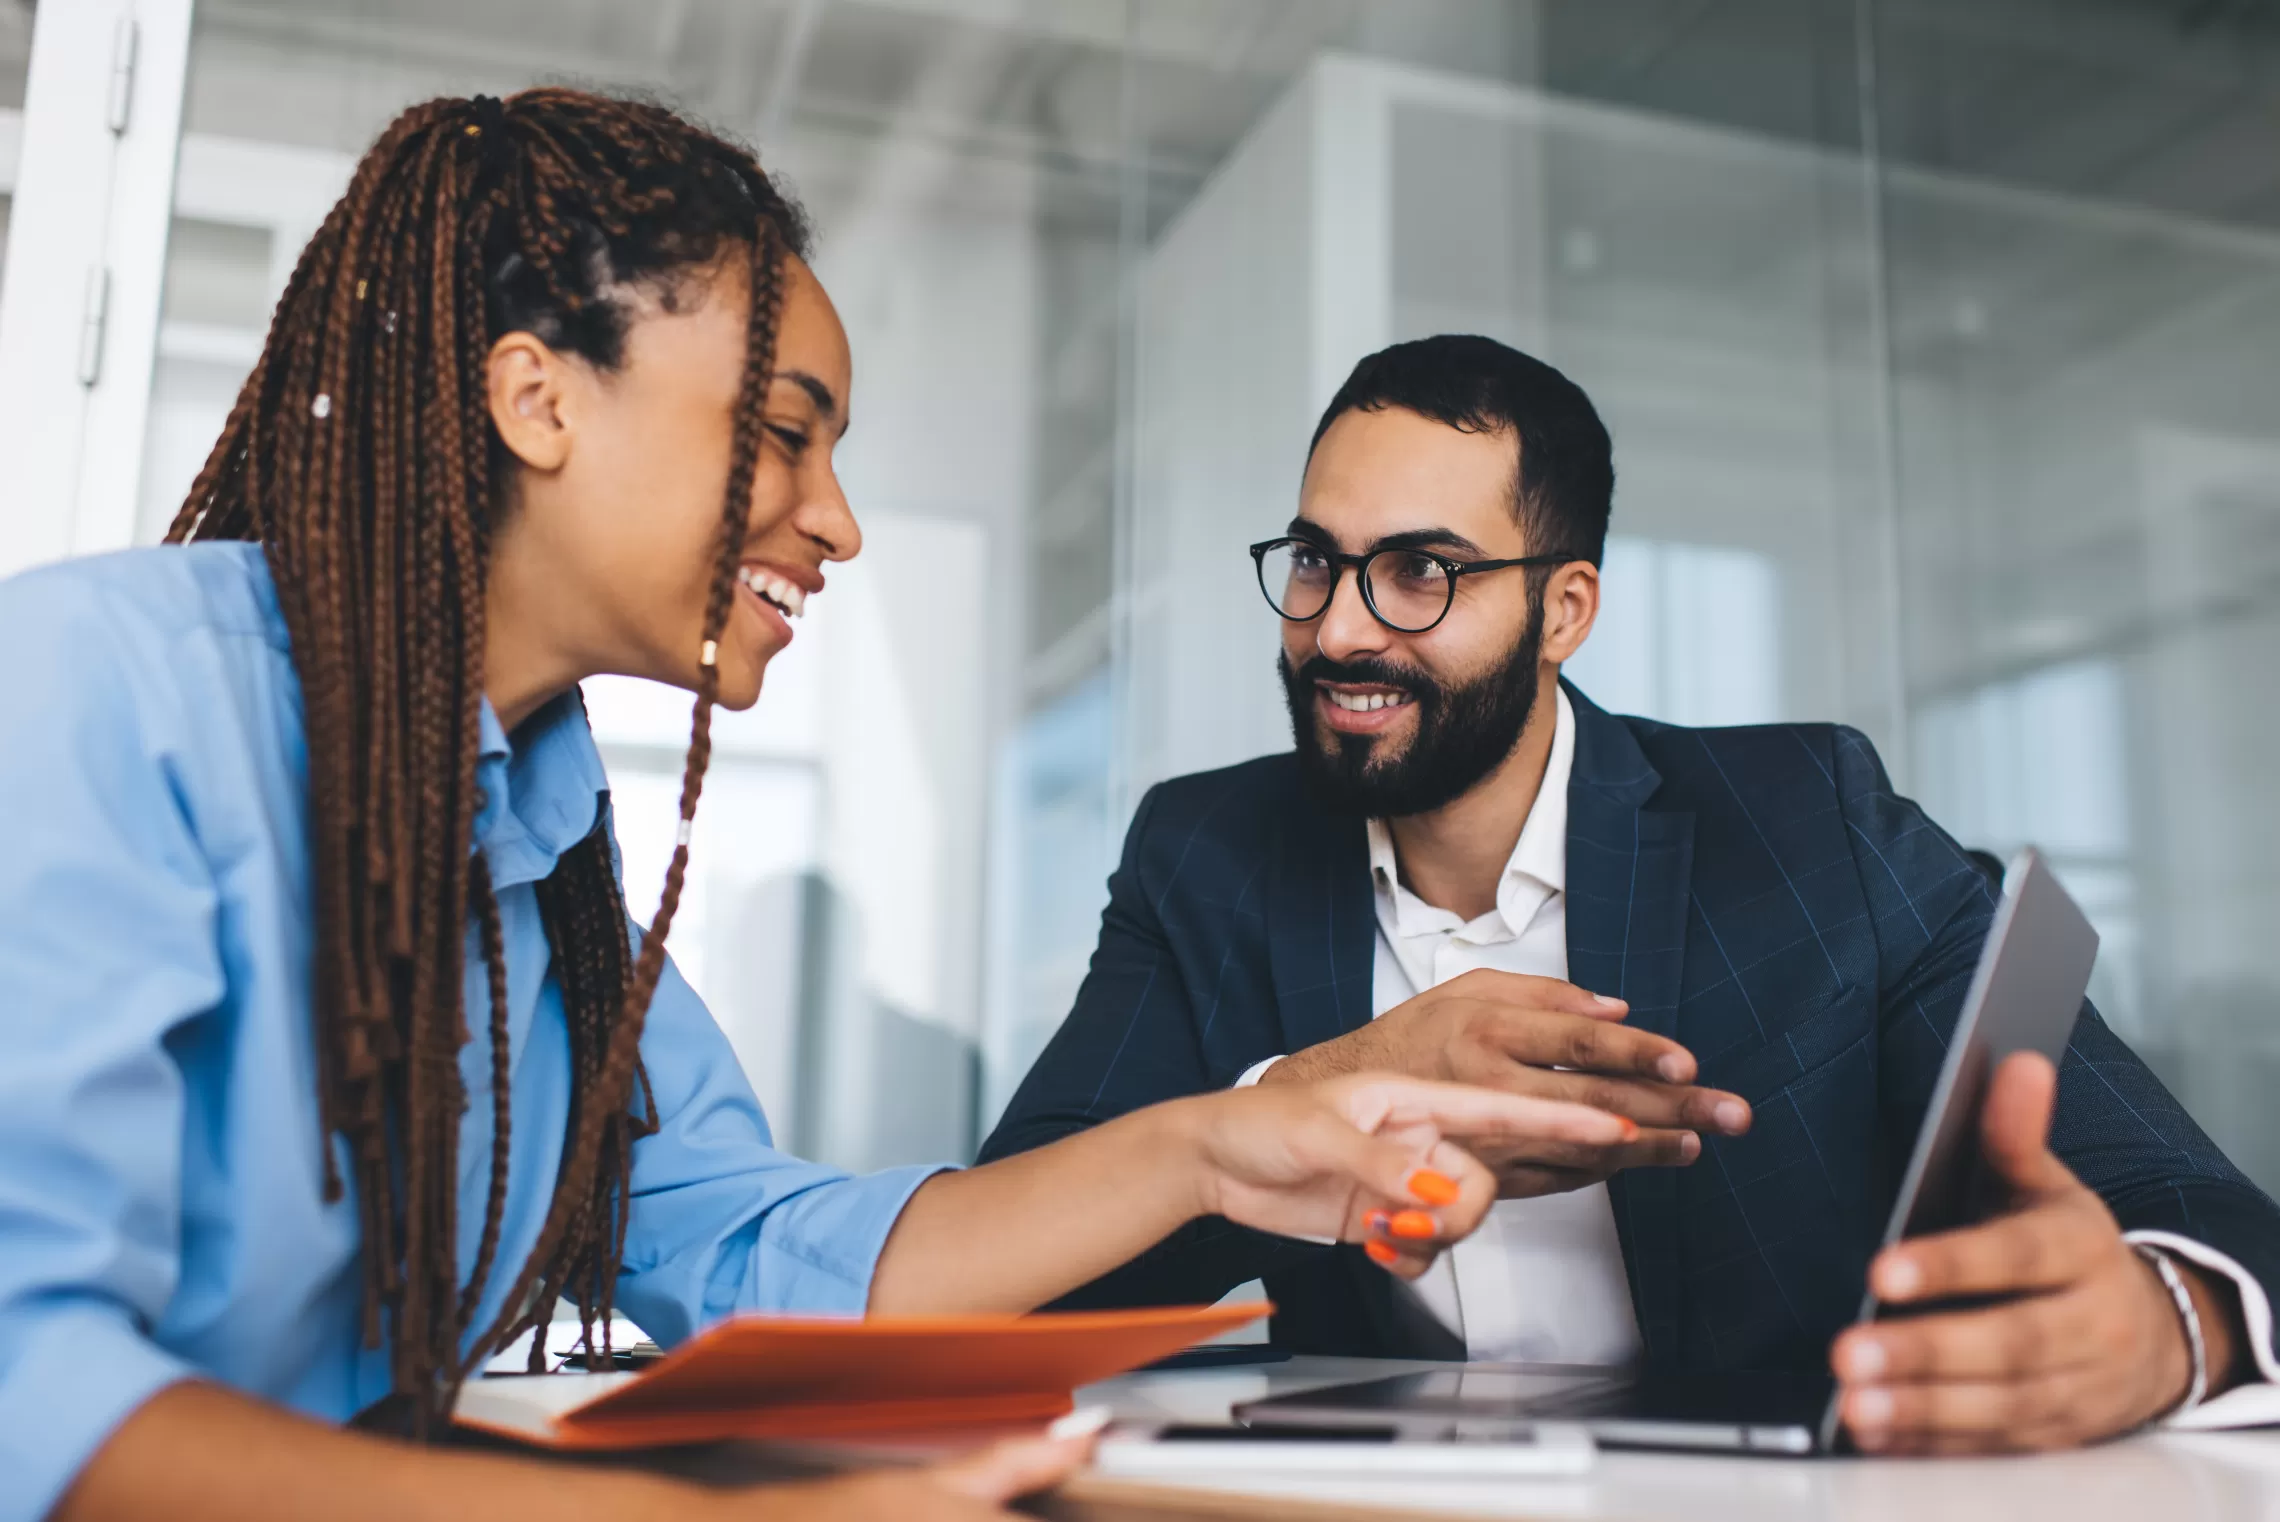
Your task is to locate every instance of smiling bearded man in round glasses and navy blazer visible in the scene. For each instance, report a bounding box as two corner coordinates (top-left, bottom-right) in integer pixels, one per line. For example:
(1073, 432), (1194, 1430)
(983, 337), (2280, 1451)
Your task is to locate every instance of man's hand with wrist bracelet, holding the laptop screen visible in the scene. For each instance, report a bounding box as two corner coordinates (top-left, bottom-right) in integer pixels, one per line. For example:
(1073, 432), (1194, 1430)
(1831, 1053), (2246, 1454)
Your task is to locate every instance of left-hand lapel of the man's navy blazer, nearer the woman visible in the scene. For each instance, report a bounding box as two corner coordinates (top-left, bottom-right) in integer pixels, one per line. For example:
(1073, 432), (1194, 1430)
(1265, 783), (1377, 1053)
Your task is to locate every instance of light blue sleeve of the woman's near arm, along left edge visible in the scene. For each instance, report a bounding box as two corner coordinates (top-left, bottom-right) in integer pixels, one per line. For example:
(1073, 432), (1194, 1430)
(0, 576), (223, 1522)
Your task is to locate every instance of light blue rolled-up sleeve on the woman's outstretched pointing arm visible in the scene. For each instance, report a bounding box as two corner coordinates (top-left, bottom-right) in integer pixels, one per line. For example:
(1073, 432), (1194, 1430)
(618, 943), (946, 1347)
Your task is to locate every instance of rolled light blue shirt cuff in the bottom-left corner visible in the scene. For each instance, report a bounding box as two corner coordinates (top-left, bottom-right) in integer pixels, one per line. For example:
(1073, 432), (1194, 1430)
(0, 1301), (192, 1522)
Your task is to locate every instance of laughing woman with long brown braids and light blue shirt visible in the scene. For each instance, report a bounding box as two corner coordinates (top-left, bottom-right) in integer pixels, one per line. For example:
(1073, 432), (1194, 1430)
(0, 89), (1628, 1522)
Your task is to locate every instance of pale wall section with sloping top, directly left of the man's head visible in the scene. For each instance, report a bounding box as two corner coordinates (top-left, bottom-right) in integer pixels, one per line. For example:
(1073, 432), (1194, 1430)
(1124, 66), (1349, 800)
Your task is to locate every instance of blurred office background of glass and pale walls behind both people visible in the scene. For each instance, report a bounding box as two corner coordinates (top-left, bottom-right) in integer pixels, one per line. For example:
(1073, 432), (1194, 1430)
(0, 0), (2280, 1187)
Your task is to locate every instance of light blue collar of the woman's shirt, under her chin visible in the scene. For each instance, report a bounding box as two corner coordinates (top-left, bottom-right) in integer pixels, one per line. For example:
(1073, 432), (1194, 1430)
(474, 688), (609, 889)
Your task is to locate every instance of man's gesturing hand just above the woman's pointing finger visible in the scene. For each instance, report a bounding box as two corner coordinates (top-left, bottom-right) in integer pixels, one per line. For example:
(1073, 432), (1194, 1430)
(1259, 971), (1749, 1198)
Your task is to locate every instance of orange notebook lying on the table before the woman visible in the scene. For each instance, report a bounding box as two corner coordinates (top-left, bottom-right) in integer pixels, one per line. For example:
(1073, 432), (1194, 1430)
(454, 1301), (1270, 1449)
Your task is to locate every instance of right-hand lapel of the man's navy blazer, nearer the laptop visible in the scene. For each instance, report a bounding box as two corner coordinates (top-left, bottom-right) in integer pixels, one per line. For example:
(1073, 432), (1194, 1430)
(1566, 688), (1694, 1363)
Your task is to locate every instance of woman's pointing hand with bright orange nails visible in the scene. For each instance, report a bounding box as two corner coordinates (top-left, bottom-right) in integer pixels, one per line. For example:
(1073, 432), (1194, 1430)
(1176, 1073), (1637, 1278)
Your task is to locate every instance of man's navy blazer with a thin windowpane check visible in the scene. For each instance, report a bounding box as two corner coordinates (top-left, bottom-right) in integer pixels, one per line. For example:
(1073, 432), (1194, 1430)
(983, 688), (2280, 1369)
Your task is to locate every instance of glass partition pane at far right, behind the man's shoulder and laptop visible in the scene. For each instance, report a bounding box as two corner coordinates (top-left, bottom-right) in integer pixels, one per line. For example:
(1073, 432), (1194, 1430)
(1876, 0), (2280, 1187)
